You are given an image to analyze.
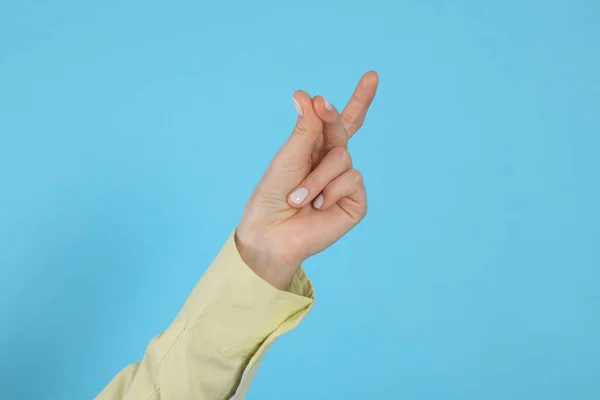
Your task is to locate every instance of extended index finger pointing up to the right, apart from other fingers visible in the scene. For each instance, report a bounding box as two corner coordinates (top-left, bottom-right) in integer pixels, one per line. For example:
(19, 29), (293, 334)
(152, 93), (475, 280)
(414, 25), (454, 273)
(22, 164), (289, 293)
(342, 71), (379, 138)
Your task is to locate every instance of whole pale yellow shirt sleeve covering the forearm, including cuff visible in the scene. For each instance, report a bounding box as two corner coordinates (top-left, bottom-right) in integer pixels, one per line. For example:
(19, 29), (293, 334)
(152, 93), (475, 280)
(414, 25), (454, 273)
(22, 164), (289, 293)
(96, 231), (314, 400)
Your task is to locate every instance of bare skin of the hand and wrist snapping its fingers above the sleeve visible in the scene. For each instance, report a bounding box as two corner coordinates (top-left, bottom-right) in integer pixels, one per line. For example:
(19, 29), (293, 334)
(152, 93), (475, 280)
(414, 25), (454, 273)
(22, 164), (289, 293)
(235, 71), (379, 290)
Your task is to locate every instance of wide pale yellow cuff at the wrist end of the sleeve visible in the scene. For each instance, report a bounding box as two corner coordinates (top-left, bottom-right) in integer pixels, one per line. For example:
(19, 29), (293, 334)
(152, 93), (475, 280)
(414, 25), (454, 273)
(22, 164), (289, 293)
(180, 231), (314, 355)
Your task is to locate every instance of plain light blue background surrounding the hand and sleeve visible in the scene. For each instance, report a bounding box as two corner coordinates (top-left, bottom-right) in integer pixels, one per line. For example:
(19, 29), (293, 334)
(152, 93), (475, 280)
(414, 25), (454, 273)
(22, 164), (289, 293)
(0, 0), (600, 400)
